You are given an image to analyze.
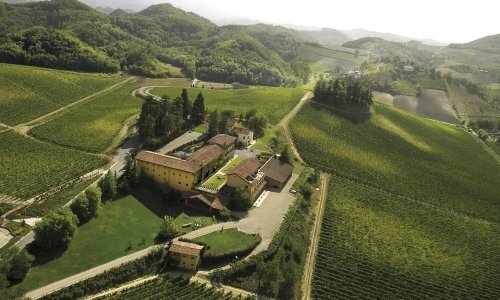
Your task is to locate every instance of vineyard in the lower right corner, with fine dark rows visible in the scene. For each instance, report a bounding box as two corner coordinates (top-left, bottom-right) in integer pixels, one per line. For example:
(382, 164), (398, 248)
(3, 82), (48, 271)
(312, 176), (500, 299)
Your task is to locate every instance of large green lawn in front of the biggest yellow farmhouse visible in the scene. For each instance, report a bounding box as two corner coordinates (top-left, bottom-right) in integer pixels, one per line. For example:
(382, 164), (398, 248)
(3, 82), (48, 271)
(15, 190), (213, 291)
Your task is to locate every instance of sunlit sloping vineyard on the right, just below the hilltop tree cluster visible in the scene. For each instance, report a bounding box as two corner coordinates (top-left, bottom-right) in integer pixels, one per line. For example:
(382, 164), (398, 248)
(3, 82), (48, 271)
(291, 104), (500, 222)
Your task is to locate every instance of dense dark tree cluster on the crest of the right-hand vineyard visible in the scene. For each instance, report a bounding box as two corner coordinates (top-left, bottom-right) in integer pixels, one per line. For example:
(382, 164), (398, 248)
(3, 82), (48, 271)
(314, 79), (373, 111)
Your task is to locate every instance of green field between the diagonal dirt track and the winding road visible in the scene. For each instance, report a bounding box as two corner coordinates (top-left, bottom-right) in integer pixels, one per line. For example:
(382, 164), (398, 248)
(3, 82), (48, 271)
(30, 84), (142, 152)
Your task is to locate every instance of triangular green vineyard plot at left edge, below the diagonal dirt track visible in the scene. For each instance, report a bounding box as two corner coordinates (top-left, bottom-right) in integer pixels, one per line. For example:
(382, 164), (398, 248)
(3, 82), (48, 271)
(0, 132), (107, 199)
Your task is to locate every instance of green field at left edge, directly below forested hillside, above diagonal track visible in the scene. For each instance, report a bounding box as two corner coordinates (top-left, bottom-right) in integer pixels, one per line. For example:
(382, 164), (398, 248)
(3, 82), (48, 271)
(0, 63), (123, 125)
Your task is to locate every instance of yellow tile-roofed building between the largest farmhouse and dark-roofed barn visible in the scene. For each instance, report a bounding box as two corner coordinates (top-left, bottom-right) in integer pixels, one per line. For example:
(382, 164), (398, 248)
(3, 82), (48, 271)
(227, 158), (266, 199)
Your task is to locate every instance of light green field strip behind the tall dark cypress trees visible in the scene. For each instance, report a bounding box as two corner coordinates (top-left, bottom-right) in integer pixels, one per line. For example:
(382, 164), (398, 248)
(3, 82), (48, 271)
(152, 87), (305, 124)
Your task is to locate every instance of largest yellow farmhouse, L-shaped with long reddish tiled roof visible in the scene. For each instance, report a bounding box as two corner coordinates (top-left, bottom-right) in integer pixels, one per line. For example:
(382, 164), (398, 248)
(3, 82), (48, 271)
(136, 134), (236, 192)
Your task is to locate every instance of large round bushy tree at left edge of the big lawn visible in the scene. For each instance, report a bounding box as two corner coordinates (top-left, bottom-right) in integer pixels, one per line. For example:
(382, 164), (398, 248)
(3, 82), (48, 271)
(33, 207), (77, 250)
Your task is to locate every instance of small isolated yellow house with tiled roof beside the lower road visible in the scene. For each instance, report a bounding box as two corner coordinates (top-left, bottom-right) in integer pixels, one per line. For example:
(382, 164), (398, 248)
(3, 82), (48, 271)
(168, 241), (203, 271)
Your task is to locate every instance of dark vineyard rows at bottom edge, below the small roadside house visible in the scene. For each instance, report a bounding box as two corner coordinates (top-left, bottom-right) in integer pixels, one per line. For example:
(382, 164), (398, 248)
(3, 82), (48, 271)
(97, 277), (241, 300)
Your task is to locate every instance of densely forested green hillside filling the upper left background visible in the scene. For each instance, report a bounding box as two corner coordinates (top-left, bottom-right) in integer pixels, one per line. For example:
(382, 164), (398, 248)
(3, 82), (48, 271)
(0, 0), (309, 86)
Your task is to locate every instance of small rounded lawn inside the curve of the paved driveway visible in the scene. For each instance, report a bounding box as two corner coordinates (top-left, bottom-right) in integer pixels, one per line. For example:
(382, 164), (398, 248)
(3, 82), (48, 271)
(193, 228), (261, 256)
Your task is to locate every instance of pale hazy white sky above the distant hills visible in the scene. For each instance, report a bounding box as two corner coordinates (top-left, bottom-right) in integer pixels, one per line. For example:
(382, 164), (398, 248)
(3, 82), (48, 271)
(166, 0), (500, 43)
